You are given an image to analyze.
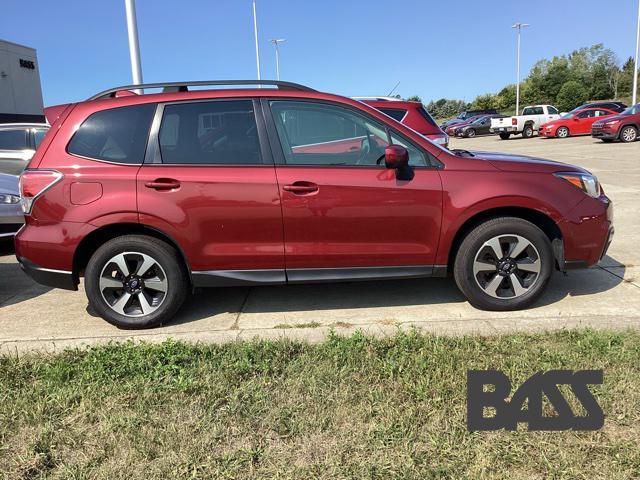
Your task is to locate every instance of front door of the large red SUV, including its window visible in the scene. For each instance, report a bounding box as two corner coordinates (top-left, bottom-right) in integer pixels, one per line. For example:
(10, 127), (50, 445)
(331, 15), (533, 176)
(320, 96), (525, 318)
(269, 100), (442, 281)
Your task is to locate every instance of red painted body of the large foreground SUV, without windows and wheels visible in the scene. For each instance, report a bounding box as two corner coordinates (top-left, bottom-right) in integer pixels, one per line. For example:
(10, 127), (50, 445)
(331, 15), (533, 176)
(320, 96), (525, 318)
(15, 82), (613, 324)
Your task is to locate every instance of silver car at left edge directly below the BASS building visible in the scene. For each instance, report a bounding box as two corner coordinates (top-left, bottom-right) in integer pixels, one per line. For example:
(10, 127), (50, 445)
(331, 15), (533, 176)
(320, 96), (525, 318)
(0, 123), (49, 175)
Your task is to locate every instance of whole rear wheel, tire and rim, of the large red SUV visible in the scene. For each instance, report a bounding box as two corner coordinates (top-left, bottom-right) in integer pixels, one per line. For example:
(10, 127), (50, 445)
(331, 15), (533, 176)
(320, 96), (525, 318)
(84, 235), (189, 329)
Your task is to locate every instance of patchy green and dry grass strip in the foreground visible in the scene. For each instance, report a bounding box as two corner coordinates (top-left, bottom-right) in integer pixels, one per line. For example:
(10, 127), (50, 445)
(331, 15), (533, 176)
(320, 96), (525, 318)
(0, 331), (640, 480)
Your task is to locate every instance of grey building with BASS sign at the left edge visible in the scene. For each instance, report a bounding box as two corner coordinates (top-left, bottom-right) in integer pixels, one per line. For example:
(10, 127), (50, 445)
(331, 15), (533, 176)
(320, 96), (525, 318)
(0, 40), (45, 123)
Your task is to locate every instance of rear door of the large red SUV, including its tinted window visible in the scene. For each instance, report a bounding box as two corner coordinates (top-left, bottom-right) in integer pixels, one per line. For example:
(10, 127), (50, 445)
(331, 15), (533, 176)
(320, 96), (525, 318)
(137, 98), (285, 285)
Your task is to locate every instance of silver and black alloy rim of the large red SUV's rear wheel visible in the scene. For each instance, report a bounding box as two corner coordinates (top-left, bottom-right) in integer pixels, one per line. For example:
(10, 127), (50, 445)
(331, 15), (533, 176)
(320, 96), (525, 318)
(98, 252), (169, 317)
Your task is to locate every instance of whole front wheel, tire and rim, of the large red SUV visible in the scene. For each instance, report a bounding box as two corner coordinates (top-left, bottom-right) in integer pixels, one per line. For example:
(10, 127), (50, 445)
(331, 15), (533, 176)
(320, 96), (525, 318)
(453, 217), (555, 311)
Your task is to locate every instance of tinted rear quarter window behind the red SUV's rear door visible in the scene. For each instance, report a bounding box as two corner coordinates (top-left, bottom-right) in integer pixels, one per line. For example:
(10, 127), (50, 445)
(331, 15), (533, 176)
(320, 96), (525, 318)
(67, 104), (156, 164)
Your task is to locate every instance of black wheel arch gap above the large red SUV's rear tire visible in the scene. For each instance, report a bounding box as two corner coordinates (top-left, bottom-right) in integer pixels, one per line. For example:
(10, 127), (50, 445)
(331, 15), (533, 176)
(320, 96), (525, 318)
(73, 223), (193, 285)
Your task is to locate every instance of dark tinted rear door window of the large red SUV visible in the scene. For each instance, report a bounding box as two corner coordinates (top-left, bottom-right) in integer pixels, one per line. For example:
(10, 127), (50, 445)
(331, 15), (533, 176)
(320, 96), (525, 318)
(159, 100), (262, 165)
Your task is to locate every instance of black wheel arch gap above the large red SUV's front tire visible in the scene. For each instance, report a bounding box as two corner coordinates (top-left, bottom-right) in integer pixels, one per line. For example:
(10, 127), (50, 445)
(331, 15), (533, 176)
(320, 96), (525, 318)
(447, 206), (564, 271)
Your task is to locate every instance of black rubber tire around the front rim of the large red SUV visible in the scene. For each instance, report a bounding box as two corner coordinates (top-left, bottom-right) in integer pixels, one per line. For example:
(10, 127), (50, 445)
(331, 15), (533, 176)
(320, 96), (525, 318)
(453, 217), (555, 311)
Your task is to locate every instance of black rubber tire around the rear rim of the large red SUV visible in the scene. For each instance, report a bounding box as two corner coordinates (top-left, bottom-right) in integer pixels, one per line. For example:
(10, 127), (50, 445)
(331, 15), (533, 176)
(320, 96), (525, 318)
(84, 235), (189, 329)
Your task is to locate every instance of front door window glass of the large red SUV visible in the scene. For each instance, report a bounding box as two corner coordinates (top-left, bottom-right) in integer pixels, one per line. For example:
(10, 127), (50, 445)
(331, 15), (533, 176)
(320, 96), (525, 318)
(271, 101), (388, 166)
